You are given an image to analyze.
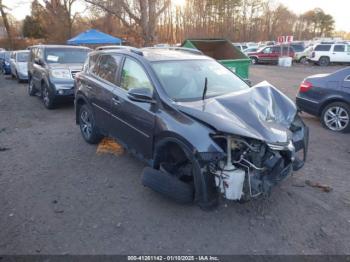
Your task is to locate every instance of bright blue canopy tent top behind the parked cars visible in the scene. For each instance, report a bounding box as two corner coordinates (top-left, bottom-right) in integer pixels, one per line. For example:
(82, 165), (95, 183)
(67, 29), (122, 45)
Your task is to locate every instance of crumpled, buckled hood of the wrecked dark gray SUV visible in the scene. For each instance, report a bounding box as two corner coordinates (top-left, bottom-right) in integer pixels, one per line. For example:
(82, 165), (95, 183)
(176, 81), (297, 143)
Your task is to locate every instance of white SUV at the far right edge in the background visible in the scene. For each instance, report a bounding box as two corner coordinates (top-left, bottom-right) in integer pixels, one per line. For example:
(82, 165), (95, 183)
(308, 43), (350, 66)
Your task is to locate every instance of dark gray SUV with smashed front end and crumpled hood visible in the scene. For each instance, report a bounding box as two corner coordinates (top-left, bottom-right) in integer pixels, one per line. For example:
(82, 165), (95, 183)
(75, 48), (308, 208)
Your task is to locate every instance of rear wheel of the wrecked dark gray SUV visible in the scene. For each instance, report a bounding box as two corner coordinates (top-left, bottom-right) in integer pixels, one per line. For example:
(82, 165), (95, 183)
(79, 104), (103, 144)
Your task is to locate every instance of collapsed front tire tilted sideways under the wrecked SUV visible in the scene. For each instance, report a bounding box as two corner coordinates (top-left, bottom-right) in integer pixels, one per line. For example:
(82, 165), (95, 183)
(142, 167), (194, 204)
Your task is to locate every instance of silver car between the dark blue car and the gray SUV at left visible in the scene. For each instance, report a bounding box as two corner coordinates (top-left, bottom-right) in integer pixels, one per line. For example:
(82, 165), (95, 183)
(10, 50), (29, 82)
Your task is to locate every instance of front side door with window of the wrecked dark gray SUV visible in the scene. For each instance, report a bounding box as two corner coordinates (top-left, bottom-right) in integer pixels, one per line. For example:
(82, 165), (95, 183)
(111, 57), (157, 159)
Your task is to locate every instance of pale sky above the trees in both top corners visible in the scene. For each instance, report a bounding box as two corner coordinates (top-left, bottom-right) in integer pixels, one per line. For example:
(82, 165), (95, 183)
(3, 0), (350, 32)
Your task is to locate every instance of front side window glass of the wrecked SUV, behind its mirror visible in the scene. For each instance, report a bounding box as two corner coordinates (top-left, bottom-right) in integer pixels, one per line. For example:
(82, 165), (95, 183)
(121, 58), (153, 93)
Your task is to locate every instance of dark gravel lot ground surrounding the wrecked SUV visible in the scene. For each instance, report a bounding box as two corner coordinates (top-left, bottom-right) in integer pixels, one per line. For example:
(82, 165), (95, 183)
(0, 66), (350, 254)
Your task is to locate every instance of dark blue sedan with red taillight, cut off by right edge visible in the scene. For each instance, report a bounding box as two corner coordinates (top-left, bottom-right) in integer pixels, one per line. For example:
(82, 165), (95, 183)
(296, 67), (350, 133)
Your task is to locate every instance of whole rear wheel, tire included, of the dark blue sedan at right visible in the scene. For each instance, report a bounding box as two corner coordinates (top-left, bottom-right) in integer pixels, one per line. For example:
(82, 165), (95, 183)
(321, 102), (350, 133)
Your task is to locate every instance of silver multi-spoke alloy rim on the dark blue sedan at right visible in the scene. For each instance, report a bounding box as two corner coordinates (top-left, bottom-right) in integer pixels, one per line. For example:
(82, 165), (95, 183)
(323, 106), (350, 131)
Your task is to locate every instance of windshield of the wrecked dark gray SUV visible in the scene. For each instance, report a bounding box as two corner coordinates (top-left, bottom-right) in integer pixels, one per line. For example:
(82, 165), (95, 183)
(152, 59), (249, 101)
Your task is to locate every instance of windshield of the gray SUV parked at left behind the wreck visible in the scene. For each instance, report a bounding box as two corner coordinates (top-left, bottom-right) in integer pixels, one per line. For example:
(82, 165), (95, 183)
(45, 48), (90, 64)
